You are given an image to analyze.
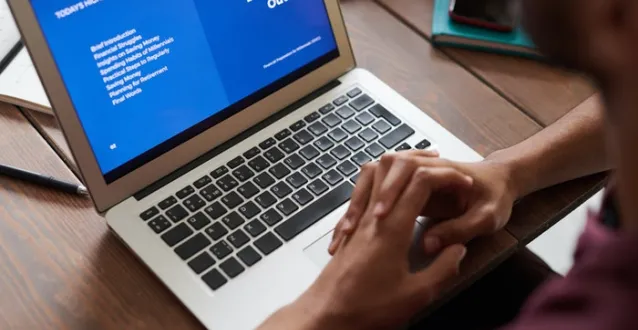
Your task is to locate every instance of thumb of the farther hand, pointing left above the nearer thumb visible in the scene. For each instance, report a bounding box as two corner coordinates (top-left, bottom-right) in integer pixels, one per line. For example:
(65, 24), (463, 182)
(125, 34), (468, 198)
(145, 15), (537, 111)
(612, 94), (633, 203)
(423, 207), (497, 255)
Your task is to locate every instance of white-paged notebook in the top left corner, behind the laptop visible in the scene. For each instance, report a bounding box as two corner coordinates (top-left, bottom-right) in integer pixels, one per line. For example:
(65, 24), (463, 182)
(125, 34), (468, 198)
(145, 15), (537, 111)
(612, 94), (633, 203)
(0, 0), (53, 114)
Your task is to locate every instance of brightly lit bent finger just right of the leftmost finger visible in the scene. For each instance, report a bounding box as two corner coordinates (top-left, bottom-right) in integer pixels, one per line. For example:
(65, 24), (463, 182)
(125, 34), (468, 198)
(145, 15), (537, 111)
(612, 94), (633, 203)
(373, 155), (417, 218)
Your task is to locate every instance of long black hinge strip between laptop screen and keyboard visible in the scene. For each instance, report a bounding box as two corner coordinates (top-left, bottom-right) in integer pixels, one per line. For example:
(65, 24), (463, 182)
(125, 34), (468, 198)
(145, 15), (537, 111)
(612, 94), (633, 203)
(133, 79), (341, 201)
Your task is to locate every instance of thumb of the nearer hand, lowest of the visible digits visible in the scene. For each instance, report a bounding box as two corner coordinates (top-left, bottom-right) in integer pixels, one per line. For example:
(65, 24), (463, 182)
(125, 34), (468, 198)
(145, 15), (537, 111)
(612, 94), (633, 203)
(411, 244), (467, 303)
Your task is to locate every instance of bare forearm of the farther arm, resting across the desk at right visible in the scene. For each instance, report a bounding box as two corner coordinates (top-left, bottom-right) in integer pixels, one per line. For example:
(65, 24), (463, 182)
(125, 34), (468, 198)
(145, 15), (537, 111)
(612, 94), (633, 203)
(488, 98), (610, 197)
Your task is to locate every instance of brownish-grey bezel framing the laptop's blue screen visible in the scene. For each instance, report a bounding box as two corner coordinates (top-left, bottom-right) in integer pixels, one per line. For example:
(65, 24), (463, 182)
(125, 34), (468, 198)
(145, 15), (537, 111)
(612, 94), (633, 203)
(8, 0), (355, 212)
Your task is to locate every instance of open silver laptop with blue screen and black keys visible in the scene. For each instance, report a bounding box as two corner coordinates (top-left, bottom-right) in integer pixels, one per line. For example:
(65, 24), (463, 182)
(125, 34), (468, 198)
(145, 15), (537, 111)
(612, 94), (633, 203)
(9, 0), (481, 329)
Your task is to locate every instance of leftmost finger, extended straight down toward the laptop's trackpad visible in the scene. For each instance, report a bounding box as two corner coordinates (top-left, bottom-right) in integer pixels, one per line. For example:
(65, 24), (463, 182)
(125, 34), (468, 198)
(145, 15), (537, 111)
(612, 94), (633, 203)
(328, 163), (378, 255)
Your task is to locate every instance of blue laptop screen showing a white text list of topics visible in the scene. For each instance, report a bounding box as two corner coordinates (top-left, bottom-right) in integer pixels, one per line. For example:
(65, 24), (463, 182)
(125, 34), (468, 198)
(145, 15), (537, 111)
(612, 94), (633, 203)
(31, 0), (339, 183)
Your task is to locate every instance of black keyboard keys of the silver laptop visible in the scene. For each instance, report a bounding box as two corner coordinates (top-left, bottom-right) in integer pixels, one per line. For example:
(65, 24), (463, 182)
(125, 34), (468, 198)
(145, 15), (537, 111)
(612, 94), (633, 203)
(140, 88), (430, 290)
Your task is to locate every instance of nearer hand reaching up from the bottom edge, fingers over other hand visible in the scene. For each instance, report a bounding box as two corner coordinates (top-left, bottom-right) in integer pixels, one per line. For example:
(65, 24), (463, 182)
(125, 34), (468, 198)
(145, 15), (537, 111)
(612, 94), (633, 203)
(262, 160), (472, 329)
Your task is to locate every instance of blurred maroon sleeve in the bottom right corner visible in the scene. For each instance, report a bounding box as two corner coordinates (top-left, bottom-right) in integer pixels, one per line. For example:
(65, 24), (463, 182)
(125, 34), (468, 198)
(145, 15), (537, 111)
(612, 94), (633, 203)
(504, 235), (638, 330)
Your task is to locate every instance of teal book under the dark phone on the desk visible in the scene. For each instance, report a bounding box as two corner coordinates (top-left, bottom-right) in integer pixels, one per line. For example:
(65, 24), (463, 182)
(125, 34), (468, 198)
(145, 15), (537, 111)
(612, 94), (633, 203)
(432, 0), (541, 58)
